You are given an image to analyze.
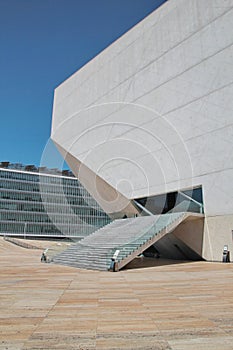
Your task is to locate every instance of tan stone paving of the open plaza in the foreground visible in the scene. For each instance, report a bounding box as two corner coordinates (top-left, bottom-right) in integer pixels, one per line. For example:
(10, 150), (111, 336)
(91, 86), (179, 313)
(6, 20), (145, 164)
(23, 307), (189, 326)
(0, 239), (233, 350)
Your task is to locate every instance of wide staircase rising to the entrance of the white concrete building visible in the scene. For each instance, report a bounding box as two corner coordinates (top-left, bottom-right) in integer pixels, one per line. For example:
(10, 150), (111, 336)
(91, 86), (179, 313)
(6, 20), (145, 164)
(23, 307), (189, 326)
(53, 205), (203, 270)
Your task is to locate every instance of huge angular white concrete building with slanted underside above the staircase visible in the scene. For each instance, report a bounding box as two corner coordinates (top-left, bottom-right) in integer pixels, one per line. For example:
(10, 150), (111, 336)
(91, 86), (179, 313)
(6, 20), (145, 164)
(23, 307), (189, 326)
(51, 0), (233, 260)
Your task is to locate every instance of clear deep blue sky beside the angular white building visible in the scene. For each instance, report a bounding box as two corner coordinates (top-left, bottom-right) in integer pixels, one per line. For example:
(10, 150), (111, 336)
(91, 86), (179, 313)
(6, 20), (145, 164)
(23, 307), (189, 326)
(0, 0), (165, 165)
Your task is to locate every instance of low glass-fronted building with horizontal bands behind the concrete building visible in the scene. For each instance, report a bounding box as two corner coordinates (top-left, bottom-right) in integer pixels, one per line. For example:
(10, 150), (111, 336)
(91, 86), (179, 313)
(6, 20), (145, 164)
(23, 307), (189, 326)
(0, 168), (110, 240)
